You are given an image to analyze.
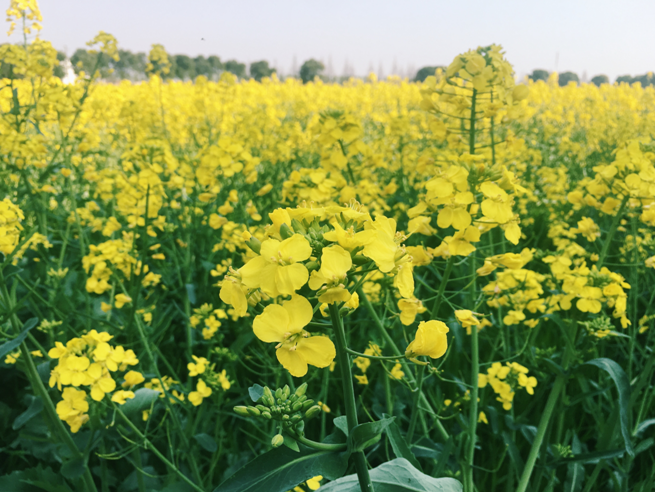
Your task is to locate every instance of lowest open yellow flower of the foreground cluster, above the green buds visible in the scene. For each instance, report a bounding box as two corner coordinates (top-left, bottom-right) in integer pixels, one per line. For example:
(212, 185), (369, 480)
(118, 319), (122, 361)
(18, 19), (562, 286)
(253, 296), (336, 377)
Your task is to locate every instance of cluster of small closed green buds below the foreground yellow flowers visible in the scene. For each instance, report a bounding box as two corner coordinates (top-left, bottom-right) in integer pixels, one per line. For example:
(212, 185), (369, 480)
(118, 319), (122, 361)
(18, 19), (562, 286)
(234, 383), (321, 432)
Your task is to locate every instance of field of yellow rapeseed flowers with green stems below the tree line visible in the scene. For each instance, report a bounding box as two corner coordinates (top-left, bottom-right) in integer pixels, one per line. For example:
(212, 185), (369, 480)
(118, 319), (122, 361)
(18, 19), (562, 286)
(0, 0), (655, 492)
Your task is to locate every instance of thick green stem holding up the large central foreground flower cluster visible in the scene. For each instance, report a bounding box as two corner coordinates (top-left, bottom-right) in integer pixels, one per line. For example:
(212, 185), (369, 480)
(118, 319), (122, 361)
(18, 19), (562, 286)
(330, 303), (374, 492)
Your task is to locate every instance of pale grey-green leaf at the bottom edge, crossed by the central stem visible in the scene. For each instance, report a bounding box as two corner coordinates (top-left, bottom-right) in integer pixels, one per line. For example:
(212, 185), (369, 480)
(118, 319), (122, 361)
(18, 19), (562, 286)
(320, 458), (462, 492)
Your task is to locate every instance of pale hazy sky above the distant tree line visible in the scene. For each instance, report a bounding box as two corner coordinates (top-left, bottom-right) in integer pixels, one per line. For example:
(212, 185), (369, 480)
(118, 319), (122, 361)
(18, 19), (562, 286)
(10, 0), (655, 80)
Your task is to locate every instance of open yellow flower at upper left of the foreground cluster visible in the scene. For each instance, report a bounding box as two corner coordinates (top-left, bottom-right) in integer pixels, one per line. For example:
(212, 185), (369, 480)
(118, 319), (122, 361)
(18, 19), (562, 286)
(239, 234), (312, 297)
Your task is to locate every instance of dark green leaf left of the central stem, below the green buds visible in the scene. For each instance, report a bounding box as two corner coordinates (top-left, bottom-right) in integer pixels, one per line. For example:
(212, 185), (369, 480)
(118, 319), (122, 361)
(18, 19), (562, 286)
(214, 446), (348, 492)
